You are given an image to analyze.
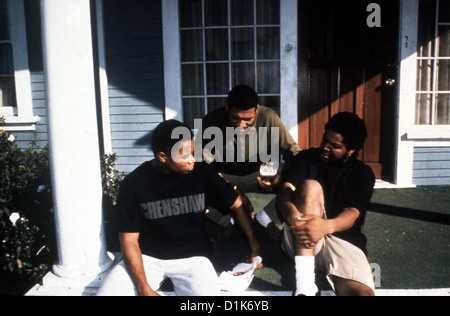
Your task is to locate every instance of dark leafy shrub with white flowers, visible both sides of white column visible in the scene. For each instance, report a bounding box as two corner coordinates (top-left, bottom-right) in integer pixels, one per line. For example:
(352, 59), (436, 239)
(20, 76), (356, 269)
(0, 117), (123, 281)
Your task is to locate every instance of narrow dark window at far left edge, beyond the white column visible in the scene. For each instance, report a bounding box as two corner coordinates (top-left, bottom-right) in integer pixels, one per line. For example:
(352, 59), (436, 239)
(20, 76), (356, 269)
(0, 0), (16, 112)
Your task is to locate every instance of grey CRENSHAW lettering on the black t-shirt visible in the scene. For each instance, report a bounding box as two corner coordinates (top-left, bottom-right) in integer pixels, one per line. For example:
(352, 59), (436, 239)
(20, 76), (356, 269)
(140, 193), (206, 220)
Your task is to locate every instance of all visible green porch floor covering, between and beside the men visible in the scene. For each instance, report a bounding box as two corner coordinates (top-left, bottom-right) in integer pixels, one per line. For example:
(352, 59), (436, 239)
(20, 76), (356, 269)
(213, 187), (450, 291)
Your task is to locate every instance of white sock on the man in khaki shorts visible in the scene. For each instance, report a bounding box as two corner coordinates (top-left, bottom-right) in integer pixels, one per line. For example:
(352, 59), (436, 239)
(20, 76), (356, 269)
(295, 256), (318, 296)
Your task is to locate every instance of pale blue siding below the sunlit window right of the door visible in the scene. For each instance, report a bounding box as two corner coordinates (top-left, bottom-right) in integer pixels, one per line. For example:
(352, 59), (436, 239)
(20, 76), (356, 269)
(413, 147), (450, 185)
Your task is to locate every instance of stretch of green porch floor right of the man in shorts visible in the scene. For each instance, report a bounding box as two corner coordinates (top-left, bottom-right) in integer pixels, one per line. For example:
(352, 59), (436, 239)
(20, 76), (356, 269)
(364, 187), (450, 289)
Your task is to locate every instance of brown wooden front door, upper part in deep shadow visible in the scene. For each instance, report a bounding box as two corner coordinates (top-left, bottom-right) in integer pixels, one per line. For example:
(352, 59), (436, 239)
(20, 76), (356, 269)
(299, 0), (399, 178)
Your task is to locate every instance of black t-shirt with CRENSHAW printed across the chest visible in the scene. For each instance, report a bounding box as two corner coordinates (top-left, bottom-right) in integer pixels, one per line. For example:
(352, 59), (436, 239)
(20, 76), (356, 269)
(117, 162), (238, 260)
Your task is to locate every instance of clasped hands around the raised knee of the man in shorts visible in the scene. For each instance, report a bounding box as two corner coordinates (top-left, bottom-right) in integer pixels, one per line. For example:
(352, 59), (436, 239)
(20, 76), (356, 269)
(290, 215), (330, 249)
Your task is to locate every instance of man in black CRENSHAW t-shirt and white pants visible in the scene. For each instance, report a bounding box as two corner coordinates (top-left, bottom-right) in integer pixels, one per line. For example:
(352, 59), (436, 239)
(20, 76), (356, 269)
(99, 120), (260, 296)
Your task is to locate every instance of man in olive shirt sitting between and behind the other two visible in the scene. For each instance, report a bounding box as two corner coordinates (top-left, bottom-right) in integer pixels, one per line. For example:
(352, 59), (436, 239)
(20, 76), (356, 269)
(202, 85), (300, 235)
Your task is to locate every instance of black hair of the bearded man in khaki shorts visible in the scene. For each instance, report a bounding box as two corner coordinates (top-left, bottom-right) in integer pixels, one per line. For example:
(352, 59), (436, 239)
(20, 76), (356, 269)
(325, 112), (367, 152)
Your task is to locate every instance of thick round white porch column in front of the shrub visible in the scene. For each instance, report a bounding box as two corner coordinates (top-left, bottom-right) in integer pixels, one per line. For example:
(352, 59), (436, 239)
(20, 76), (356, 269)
(41, 0), (112, 279)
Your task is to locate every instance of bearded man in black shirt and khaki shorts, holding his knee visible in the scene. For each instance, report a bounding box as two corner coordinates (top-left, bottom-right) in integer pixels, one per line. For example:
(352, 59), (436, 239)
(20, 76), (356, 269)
(277, 112), (375, 296)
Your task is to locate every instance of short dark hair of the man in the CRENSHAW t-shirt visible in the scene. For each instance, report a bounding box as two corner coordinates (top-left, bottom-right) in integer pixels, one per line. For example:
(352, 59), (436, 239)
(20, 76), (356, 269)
(152, 120), (194, 157)
